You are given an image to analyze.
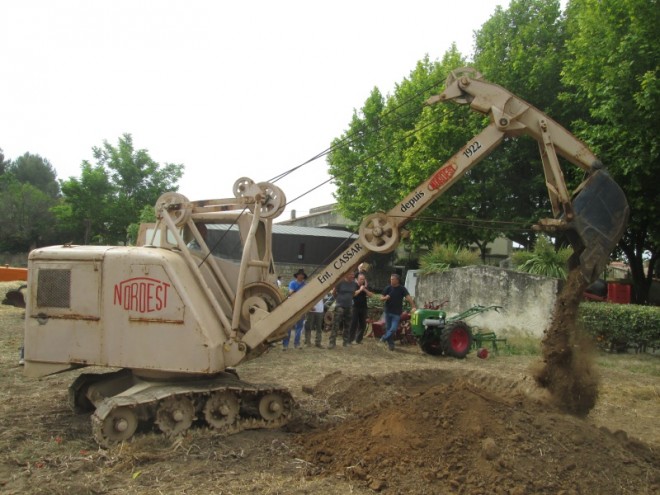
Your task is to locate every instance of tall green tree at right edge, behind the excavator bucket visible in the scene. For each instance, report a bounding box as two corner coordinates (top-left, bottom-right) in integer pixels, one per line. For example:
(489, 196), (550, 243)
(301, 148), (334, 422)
(563, 0), (660, 304)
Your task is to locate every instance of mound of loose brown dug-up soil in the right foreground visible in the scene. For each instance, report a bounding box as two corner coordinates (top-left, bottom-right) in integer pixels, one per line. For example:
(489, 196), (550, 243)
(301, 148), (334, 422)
(298, 371), (660, 494)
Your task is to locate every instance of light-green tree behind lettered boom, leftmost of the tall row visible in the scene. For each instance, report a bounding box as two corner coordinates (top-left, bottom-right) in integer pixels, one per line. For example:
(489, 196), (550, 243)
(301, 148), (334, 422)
(328, 46), (496, 256)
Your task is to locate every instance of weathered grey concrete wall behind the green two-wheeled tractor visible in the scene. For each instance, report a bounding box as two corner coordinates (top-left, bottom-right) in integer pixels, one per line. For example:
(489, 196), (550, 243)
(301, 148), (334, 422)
(415, 265), (561, 337)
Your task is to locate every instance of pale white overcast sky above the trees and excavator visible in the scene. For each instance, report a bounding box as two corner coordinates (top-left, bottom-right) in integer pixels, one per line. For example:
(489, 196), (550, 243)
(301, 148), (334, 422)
(0, 0), (509, 221)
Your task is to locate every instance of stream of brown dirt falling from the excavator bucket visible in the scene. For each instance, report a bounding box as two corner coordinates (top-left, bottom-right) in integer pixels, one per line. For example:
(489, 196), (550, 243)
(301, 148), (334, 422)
(534, 269), (598, 416)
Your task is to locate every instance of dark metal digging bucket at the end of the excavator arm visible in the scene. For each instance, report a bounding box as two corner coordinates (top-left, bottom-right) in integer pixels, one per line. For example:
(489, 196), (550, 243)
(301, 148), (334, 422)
(567, 169), (629, 283)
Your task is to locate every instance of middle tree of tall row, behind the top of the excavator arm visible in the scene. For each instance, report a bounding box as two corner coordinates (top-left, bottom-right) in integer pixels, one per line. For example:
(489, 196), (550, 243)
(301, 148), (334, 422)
(474, 0), (568, 247)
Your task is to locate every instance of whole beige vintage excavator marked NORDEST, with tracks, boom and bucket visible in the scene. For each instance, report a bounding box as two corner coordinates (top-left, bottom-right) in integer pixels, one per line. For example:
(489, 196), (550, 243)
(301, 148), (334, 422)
(24, 68), (628, 446)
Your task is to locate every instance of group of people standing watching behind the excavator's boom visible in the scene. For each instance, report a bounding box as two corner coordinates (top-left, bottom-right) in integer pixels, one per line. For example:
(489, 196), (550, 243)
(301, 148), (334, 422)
(282, 263), (415, 350)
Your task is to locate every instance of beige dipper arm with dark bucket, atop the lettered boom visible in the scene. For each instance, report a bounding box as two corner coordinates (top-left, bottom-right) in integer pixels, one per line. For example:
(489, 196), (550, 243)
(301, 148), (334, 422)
(428, 68), (629, 283)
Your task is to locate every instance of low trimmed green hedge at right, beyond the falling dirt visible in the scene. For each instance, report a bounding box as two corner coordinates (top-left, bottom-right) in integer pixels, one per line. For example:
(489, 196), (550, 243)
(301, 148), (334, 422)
(579, 302), (660, 350)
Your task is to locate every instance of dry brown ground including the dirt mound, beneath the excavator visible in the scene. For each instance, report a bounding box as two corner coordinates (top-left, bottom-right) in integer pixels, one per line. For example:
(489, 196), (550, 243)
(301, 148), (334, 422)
(0, 284), (660, 494)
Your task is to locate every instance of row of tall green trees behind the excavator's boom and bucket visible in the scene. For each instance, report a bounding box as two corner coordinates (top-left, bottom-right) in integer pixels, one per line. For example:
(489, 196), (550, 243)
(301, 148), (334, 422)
(328, 0), (660, 302)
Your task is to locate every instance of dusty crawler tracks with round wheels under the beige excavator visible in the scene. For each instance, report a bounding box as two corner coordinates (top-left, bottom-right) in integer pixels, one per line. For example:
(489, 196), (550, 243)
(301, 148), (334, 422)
(69, 370), (294, 447)
